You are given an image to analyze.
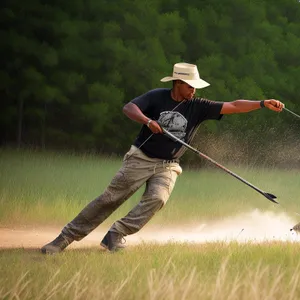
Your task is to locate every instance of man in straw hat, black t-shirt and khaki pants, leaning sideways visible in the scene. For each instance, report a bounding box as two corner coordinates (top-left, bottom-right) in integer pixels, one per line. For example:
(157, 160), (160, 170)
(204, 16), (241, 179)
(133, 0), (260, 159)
(41, 63), (284, 254)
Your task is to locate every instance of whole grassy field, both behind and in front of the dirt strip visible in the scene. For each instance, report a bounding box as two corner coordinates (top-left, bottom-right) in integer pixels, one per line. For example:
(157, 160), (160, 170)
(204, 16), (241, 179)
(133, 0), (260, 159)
(0, 149), (300, 300)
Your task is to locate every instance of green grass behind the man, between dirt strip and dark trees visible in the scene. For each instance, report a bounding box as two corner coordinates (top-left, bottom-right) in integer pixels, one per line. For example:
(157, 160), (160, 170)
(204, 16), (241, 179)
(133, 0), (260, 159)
(0, 149), (300, 225)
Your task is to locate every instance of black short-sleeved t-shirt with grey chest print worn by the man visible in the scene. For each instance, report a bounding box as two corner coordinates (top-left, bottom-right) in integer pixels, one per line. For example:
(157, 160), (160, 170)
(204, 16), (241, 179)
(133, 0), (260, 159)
(131, 89), (223, 160)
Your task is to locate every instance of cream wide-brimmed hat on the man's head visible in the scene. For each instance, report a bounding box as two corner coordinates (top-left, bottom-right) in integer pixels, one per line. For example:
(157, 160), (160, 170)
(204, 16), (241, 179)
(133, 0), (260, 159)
(160, 63), (209, 89)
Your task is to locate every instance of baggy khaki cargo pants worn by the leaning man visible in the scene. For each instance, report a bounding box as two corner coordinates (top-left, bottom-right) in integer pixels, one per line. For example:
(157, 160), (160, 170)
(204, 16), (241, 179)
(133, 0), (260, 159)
(62, 146), (182, 241)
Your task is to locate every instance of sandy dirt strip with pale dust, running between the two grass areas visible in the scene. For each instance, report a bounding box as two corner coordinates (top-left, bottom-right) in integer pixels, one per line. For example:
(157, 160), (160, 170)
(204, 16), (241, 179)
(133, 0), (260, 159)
(0, 210), (300, 249)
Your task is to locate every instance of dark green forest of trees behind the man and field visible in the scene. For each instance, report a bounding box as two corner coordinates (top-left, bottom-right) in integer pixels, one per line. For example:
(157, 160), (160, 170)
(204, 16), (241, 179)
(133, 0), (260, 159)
(0, 0), (300, 165)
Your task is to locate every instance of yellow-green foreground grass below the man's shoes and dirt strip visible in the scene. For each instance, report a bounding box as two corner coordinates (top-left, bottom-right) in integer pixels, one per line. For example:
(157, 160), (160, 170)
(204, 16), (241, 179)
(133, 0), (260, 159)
(0, 243), (300, 300)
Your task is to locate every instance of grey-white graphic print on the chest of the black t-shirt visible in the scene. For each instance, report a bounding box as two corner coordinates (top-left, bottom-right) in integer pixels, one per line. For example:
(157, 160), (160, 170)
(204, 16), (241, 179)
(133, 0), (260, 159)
(158, 111), (187, 139)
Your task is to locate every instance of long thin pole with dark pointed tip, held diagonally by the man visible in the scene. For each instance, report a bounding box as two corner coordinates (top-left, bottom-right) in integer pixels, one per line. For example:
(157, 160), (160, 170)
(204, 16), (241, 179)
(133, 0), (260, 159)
(162, 127), (278, 204)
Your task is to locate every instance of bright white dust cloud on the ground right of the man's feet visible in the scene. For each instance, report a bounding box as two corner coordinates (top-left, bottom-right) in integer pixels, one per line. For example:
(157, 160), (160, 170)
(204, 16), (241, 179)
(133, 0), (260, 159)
(137, 210), (300, 243)
